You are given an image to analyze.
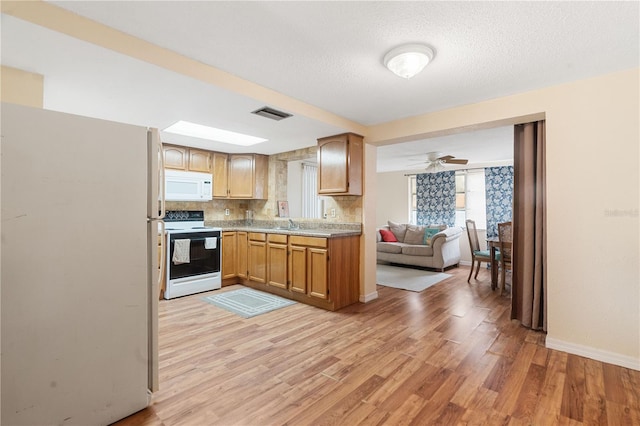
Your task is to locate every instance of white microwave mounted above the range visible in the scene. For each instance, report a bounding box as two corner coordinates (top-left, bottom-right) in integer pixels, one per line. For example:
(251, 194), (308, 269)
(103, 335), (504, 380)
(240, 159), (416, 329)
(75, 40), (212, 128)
(164, 170), (213, 201)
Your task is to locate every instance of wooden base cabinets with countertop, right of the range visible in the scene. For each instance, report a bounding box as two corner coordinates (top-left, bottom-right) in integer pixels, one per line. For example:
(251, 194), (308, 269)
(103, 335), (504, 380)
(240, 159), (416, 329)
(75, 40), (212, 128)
(213, 221), (361, 311)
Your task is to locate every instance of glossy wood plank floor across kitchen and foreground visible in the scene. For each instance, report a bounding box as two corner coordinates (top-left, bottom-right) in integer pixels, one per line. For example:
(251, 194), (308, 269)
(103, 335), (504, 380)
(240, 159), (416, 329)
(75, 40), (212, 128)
(118, 267), (640, 426)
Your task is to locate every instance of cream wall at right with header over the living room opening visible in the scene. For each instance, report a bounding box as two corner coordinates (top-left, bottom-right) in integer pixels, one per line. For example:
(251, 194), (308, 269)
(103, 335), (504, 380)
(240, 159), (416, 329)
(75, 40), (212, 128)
(365, 69), (640, 369)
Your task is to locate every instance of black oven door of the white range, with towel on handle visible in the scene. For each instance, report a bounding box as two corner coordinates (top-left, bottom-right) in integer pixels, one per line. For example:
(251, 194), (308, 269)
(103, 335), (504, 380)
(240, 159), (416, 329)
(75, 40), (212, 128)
(167, 231), (221, 280)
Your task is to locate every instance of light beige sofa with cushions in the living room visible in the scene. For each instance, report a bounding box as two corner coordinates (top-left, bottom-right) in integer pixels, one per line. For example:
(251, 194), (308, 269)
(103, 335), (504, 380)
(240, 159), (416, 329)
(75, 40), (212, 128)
(376, 222), (462, 271)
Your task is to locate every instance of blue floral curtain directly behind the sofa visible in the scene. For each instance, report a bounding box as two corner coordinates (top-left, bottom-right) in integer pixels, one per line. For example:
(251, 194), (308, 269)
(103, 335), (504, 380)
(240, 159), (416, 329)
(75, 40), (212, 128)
(416, 171), (456, 226)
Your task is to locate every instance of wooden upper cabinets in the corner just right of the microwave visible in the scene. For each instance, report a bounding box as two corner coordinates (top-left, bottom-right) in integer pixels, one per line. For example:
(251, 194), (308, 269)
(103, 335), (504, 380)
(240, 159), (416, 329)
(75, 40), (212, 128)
(213, 152), (269, 200)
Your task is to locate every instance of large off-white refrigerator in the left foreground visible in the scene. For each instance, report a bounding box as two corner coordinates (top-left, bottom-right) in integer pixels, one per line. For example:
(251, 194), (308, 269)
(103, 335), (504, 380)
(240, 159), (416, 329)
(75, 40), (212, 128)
(0, 103), (164, 425)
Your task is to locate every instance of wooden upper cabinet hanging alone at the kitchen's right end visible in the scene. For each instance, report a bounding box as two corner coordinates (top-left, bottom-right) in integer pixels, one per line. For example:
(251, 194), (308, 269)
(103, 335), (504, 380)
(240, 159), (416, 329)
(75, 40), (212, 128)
(318, 133), (363, 195)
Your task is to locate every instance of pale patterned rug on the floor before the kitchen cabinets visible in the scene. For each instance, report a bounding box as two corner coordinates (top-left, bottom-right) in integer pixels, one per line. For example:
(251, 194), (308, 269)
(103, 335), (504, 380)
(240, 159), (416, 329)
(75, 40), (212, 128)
(202, 288), (296, 318)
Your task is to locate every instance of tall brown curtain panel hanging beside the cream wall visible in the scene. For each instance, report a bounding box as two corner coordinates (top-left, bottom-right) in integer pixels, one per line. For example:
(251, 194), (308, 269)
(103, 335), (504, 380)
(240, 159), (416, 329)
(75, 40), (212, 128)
(511, 121), (547, 331)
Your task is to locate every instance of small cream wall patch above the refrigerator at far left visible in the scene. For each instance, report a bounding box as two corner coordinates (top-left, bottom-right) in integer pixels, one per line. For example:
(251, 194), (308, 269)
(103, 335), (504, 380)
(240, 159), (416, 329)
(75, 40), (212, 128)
(0, 66), (44, 108)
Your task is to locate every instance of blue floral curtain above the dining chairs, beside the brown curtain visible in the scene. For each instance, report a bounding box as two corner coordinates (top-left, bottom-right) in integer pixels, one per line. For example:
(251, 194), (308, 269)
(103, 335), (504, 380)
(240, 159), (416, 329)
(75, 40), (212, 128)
(484, 166), (513, 237)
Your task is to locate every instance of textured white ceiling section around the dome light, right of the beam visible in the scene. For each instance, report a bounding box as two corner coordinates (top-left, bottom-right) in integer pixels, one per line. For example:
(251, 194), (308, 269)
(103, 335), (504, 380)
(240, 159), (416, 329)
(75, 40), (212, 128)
(54, 1), (639, 124)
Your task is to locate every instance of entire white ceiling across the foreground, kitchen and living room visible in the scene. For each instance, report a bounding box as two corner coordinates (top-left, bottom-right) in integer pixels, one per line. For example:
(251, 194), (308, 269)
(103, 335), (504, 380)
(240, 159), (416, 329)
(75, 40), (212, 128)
(1, 1), (640, 171)
